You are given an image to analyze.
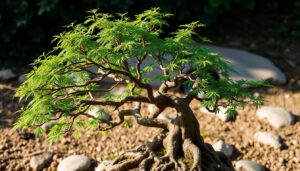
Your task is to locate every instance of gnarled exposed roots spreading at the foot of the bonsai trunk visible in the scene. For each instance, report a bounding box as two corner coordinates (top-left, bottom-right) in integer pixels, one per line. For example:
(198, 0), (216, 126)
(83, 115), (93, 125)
(99, 134), (233, 171)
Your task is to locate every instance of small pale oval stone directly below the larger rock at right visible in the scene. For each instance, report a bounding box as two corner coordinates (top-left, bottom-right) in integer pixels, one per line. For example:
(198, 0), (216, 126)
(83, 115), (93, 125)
(254, 131), (282, 148)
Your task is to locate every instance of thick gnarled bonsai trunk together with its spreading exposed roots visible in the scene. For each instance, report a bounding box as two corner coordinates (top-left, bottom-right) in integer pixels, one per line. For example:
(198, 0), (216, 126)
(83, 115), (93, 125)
(105, 101), (234, 171)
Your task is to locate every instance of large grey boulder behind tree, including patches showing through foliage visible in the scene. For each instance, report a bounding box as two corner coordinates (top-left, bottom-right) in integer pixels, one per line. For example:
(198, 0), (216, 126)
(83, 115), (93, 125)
(90, 45), (286, 88)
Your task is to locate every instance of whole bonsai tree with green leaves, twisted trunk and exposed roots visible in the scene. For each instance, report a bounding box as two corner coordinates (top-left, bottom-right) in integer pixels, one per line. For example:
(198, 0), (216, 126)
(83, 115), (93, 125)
(15, 8), (261, 171)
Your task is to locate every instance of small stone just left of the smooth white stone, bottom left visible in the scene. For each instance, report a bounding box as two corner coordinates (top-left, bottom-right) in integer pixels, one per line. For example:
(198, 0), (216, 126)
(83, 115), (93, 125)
(30, 152), (53, 170)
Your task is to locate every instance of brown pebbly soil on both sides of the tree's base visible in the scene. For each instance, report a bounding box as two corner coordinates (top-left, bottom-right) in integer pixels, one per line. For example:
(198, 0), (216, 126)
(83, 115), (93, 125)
(0, 82), (300, 171)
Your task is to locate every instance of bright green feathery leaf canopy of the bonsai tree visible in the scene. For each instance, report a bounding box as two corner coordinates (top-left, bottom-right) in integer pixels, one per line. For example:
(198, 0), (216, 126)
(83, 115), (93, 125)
(15, 8), (263, 140)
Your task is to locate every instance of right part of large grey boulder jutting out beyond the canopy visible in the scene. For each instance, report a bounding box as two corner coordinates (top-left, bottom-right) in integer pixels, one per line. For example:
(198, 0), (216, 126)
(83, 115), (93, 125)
(206, 46), (286, 83)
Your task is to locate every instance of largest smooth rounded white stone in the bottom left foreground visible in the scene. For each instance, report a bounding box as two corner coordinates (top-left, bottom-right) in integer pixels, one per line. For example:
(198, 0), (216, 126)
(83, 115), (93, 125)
(57, 155), (91, 171)
